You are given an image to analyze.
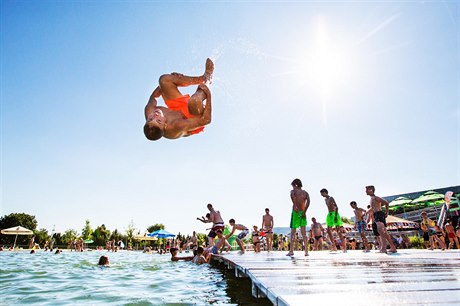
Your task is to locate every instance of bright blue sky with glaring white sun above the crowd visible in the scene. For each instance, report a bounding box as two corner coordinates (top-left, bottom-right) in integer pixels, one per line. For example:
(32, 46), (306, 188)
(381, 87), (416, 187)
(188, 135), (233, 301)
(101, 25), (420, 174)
(0, 1), (460, 233)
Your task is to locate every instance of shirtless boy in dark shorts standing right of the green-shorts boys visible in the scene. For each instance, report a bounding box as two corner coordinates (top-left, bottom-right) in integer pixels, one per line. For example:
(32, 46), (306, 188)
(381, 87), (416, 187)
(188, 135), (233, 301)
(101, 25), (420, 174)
(366, 186), (397, 253)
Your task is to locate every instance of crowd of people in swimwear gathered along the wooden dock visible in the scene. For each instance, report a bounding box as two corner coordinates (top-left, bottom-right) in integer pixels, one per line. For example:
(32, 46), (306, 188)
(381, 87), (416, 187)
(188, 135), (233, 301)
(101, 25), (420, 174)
(173, 178), (459, 263)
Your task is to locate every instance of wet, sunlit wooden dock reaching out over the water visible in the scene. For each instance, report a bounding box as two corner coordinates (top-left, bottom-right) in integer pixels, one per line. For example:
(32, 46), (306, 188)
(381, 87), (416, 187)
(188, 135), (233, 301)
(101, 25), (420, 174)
(213, 249), (460, 306)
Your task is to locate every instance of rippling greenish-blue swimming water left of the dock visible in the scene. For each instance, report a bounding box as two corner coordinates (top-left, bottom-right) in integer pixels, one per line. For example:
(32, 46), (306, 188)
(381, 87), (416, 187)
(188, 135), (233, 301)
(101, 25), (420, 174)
(0, 251), (270, 305)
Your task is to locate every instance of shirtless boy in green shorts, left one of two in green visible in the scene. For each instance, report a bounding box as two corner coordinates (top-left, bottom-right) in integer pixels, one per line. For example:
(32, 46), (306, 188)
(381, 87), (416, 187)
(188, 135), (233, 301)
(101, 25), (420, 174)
(286, 179), (310, 256)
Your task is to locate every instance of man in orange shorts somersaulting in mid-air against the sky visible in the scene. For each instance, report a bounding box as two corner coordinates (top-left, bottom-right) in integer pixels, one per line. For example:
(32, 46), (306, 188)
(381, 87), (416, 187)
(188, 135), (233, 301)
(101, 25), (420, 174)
(144, 58), (214, 140)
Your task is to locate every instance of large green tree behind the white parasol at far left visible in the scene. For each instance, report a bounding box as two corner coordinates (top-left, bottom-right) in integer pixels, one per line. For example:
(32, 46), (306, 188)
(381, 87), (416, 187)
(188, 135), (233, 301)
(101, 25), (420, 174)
(0, 213), (38, 245)
